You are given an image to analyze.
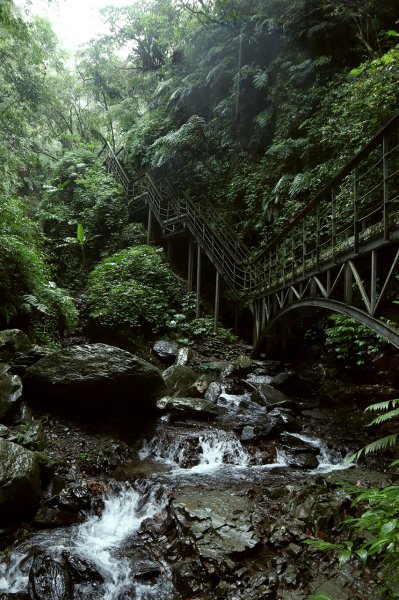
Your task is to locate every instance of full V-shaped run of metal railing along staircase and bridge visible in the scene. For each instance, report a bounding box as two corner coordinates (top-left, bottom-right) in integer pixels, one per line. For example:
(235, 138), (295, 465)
(101, 113), (399, 300)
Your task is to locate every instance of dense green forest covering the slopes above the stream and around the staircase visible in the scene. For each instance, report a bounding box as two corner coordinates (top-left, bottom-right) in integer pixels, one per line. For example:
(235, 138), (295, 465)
(0, 0), (399, 352)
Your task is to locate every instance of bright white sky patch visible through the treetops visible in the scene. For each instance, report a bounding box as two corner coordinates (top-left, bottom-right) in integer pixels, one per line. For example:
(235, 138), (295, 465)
(15, 0), (132, 50)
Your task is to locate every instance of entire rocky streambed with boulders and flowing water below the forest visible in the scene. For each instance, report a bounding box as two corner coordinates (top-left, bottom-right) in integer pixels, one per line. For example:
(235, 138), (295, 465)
(0, 332), (395, 600)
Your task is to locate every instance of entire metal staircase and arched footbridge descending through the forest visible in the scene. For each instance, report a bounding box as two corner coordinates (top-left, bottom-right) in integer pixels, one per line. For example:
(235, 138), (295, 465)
(100, 113), (399, 348)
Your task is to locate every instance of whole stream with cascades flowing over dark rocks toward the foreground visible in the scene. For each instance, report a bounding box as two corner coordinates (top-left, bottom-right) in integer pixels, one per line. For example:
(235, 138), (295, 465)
(0, 354), (388, 600)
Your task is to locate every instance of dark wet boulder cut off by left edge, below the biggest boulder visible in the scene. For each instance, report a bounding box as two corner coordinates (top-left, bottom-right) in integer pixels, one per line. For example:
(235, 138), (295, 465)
(0, 438), (42, 523)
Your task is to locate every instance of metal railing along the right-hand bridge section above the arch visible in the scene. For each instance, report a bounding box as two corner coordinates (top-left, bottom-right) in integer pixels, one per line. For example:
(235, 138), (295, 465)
(251, 114), (399, 297)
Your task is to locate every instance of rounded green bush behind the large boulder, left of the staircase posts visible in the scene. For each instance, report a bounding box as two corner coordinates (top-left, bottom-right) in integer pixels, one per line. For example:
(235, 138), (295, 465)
(87, 246), (180, 332)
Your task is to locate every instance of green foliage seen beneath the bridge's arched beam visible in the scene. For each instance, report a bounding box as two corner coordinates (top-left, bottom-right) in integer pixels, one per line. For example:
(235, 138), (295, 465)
(324, 314), (385, 368)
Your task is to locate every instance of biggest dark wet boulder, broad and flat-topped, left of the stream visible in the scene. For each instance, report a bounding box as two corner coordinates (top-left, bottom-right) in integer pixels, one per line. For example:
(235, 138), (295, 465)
(23, 344), (165, 417)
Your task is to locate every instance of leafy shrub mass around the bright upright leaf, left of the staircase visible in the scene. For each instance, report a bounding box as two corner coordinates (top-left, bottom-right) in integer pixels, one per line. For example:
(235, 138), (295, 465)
(36, 148), (128, 286)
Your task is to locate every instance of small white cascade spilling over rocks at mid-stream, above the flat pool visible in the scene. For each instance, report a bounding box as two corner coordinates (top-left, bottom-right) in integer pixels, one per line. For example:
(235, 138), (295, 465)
(139, 430), (250, 473)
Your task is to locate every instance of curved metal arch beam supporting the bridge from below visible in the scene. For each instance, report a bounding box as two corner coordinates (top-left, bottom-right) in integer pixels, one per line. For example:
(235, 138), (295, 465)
(254, 298), (399, 354)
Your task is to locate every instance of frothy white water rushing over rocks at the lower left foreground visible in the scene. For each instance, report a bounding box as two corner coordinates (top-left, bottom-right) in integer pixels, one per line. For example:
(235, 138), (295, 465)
(0, 487), (172, 600)
